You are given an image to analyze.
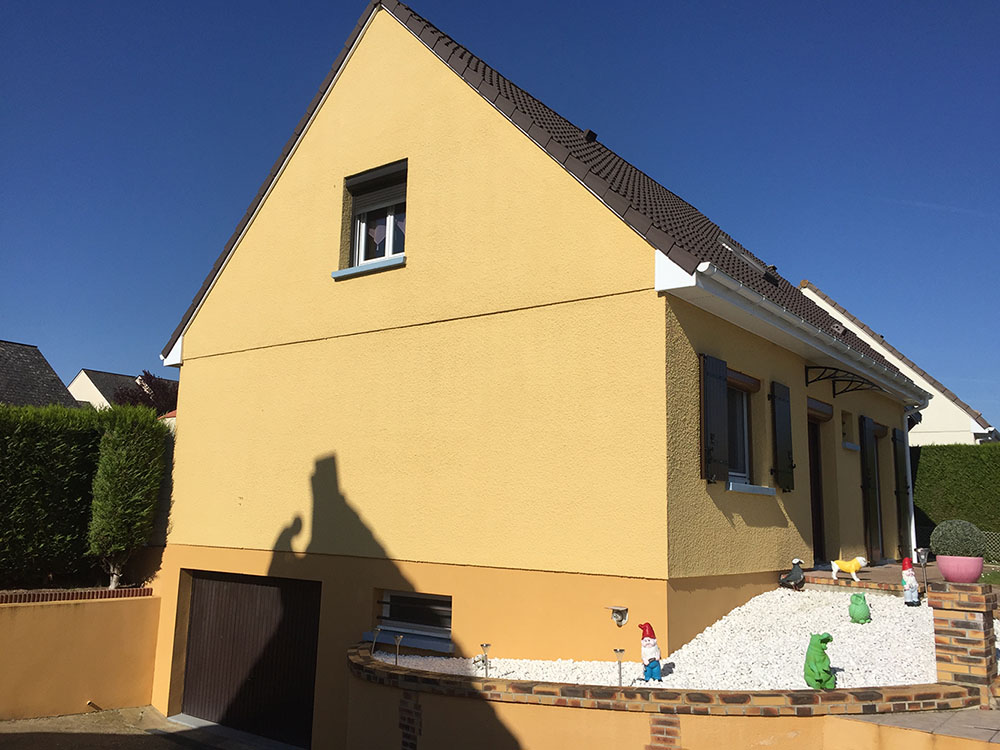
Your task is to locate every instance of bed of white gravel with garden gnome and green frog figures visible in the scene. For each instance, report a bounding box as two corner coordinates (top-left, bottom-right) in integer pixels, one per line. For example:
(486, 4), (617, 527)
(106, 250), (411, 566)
(375, 589), (1000, 690)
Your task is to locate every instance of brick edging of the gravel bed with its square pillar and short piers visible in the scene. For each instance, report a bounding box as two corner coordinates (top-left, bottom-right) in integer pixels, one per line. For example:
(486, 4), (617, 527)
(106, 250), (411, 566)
(347, 583), (1000, 750)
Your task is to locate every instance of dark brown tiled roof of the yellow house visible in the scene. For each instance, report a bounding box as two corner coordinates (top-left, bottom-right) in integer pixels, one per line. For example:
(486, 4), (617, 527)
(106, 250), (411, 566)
(162, 0), (897, 371)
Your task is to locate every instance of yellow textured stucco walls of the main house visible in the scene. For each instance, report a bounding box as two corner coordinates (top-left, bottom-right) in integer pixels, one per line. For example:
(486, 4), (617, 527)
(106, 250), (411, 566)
(153, 4), (924, 747)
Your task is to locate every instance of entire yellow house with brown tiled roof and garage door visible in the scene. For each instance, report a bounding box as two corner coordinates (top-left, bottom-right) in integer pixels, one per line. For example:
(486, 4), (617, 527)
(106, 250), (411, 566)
(146, 1), (927, 747)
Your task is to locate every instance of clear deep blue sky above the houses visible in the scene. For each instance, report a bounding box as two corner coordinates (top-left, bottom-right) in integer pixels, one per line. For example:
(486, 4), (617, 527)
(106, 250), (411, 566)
(0, 0), (1000, 424)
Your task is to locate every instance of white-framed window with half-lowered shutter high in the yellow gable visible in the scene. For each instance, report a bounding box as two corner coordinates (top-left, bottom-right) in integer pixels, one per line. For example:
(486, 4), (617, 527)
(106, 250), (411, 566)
(352, 183), (406, 266)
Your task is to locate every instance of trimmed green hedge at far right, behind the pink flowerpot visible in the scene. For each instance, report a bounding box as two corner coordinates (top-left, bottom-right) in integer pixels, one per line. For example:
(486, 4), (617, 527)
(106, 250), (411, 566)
(910, 443), (1000, 535)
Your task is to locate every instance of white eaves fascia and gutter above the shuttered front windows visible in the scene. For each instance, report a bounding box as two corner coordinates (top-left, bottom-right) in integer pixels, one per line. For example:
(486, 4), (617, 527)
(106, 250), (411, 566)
(656, 258), (930, 409)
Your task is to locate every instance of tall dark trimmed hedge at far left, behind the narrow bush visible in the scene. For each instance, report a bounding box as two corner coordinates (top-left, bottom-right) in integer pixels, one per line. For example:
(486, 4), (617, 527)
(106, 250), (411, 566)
(0, 405), (164, 588)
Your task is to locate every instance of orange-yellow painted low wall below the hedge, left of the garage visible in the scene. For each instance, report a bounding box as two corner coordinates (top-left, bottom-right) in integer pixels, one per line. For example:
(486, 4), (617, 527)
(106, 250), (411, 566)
(0, 597), (160, 719)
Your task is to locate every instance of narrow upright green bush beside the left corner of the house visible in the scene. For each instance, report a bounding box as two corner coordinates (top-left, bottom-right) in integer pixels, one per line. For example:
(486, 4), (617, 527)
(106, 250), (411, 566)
(87, 409), (167, 588)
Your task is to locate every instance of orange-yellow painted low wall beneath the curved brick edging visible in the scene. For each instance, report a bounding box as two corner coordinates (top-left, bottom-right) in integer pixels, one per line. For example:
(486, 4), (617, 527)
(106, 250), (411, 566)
(347, 680), (994, 750)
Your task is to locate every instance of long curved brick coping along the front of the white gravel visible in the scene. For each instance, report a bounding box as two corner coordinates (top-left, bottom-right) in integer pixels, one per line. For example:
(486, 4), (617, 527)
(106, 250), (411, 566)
(347, 644), (980, 716)
